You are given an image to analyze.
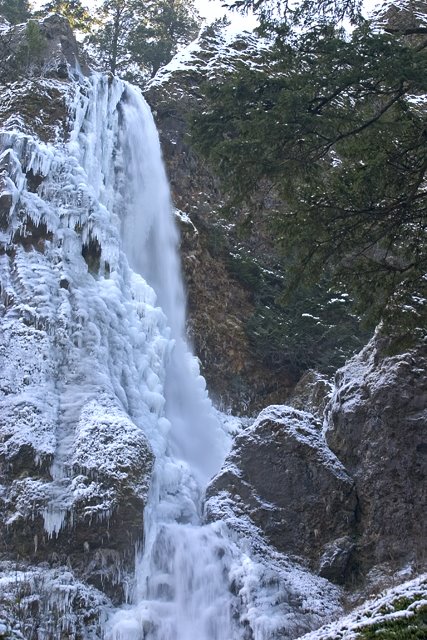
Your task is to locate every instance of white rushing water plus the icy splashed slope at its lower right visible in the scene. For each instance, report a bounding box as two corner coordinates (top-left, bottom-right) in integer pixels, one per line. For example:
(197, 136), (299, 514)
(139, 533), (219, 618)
(66, 76), (344, 640)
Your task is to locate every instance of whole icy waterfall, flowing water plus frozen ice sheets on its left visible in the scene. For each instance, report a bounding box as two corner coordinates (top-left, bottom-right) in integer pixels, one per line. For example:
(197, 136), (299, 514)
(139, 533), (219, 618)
(0, 75), (339, 640)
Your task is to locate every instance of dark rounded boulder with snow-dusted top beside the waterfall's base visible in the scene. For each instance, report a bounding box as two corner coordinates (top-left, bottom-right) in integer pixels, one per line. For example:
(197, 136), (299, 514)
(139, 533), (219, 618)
(206, 406), (357, 582)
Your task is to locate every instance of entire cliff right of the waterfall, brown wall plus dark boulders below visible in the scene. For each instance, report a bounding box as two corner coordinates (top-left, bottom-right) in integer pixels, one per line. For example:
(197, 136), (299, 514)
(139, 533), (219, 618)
(147, 3), (427, 586)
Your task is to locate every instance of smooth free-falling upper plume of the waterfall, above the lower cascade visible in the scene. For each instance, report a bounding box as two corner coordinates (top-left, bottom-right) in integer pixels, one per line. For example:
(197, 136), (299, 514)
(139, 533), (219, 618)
(120, 86), (225, 482)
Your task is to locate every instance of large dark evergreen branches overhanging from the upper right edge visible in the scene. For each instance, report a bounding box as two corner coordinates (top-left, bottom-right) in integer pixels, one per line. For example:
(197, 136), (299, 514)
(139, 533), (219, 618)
(192, 16), (427, 330)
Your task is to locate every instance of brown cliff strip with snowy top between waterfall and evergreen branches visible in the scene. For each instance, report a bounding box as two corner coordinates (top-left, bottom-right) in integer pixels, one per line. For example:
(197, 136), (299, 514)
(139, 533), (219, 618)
(145, 27), (296, 414)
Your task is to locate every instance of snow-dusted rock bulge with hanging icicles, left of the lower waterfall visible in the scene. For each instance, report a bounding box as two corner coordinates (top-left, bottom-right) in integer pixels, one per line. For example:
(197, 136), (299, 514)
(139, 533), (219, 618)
(0, 330), (153, 601)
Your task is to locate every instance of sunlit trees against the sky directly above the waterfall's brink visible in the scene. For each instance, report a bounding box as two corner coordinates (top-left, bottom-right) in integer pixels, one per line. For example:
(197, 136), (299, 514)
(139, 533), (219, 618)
(89, 0), (199, 79)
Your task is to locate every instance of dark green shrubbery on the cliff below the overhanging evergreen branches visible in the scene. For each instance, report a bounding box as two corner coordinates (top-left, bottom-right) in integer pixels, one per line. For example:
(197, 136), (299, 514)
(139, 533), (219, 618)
(224, 245), (369, 379)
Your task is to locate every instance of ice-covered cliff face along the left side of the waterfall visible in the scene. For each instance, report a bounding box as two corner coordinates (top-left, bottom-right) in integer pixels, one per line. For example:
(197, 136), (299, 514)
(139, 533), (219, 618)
(0, 16), (162, 638)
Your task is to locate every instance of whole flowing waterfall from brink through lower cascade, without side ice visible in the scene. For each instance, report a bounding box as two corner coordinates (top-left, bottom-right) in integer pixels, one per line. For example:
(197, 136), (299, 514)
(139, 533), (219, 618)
(70, 76), (240, 640)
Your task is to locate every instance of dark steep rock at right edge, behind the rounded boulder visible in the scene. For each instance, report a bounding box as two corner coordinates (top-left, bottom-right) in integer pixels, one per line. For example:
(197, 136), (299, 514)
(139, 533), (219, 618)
(326, 333), (427, 575)
